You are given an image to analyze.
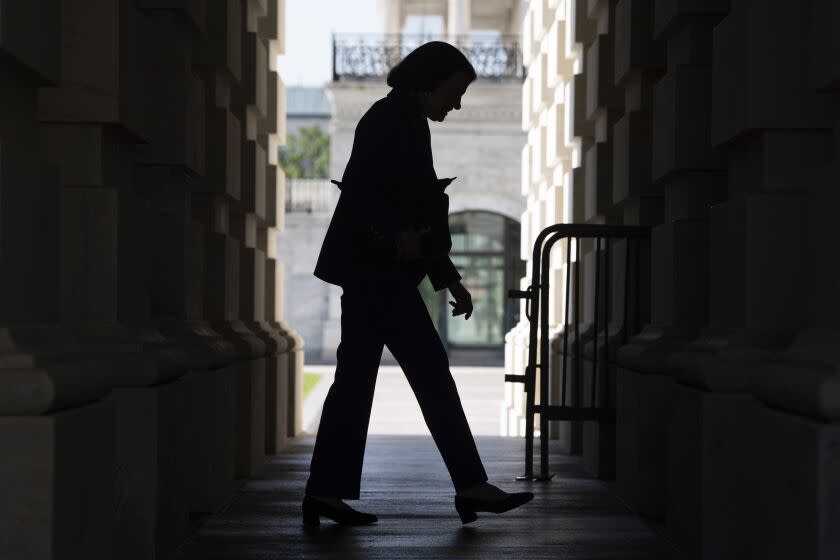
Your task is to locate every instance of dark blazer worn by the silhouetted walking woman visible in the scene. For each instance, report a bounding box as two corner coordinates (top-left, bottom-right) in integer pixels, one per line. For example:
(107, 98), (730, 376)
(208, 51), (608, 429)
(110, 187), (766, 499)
(314, 88), (461, 290)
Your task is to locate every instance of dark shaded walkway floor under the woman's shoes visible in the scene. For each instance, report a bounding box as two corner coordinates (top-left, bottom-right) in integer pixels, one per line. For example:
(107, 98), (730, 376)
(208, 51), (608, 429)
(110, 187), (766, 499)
(179, 434), (682, 560)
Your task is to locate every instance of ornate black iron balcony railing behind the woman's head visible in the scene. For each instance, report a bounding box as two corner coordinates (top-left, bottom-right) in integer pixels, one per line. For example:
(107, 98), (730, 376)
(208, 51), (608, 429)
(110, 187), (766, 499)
(333, 33), (525, 82)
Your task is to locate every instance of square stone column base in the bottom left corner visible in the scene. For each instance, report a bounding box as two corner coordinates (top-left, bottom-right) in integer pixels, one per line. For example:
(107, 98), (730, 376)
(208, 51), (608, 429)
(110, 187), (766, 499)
(0, 401), (115, 560)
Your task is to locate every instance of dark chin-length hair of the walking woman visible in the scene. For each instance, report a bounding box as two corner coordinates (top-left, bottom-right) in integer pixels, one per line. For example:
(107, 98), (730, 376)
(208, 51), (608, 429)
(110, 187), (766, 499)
(387, 41), (476, 91)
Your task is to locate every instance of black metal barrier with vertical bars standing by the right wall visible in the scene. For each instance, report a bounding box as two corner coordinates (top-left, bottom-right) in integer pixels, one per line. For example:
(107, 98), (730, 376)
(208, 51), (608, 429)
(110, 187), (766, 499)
(505, 224), (650, 480)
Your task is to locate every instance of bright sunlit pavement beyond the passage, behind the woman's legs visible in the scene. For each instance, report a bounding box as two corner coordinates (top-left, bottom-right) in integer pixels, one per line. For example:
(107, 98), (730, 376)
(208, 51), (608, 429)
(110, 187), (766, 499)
(303, 365), (505, 437)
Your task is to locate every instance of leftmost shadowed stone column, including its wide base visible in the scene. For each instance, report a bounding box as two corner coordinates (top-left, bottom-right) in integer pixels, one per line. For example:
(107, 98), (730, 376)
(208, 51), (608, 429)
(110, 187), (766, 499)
(0, 5), (114, 559)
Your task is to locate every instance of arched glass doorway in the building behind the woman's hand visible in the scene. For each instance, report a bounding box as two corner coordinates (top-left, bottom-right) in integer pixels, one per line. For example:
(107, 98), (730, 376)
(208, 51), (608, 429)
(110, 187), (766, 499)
(420, 211), (525, 365)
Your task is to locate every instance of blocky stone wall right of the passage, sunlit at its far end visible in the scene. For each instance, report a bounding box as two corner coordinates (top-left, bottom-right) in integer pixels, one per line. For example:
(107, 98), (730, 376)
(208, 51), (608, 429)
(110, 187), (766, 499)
(508, 0), (840, 559)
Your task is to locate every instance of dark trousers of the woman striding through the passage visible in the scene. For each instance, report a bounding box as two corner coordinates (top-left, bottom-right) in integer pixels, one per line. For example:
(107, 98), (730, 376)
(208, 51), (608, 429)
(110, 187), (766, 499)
(306, 279), (487, 500)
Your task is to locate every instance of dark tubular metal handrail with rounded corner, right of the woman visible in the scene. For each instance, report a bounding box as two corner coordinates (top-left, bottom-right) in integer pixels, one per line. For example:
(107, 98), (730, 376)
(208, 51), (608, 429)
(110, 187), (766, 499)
(505, 224), (650, 480)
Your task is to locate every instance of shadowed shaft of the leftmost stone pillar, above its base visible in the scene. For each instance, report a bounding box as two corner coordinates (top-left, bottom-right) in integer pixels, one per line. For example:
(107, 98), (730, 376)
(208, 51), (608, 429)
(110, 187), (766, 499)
(0, 5), (61, 325)
